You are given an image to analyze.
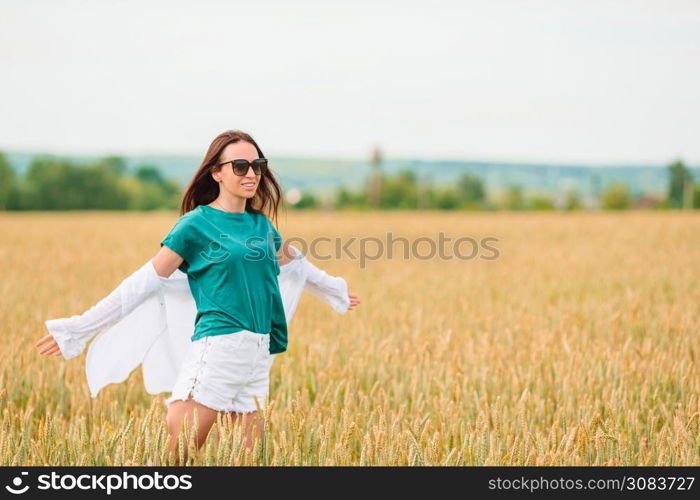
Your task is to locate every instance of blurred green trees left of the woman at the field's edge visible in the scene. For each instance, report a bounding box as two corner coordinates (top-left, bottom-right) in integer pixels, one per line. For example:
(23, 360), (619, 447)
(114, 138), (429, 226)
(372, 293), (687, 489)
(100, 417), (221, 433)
(0, 153), (182, 210)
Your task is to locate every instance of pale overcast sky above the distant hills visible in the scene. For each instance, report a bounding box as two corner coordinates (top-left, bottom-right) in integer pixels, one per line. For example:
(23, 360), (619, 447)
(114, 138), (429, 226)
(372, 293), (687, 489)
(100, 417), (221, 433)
(0, 0), (700, 164)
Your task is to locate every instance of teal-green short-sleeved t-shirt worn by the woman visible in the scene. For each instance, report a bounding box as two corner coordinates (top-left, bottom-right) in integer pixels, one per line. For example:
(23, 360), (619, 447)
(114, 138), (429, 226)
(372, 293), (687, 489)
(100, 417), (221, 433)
(160, 205), (287, 354)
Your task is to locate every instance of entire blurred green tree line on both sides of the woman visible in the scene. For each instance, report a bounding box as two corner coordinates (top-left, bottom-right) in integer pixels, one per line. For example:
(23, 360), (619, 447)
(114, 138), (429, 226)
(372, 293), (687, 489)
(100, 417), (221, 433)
(0, 152), (700, 210)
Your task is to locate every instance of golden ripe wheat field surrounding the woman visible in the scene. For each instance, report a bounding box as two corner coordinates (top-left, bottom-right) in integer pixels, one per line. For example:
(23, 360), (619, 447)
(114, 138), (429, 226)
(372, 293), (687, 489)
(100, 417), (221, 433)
(0, 211), (700, 465)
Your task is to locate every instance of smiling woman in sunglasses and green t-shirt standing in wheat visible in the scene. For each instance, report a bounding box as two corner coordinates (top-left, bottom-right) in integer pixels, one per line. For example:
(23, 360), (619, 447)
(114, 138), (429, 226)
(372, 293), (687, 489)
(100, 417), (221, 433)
(37, 131), (359, 460)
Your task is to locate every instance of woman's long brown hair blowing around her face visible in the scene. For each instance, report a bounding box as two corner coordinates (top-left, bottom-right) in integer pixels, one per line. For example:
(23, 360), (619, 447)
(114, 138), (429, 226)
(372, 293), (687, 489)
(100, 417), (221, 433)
(180, 130), (282, 226)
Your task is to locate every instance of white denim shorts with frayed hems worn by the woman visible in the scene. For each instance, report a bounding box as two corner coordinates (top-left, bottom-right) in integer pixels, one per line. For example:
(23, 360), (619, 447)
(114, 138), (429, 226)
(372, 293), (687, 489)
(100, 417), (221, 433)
(165, 330), (275, 413)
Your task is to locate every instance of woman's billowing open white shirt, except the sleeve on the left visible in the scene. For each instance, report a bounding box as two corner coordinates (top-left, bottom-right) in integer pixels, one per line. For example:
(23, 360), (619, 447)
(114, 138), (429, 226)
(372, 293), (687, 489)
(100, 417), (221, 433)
(80, 245), (350, 398)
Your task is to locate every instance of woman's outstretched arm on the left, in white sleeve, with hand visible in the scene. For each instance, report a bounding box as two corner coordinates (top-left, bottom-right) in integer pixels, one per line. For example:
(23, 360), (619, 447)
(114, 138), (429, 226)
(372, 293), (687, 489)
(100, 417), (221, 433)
(35, 246), (183, 359)
